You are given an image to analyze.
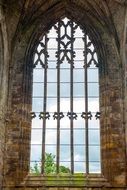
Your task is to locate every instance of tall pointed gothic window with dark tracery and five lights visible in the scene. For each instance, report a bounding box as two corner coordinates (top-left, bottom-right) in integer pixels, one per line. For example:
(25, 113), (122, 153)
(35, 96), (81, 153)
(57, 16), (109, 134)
(30, 18), (101, 173)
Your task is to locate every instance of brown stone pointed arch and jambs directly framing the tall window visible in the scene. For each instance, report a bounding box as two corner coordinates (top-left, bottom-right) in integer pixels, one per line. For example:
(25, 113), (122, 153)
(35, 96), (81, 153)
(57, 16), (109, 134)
(1, 1), (125, 189)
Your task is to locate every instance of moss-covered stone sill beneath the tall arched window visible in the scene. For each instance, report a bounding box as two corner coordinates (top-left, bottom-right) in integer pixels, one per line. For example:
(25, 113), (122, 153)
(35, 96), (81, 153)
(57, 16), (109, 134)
(21, 174), (110, 187)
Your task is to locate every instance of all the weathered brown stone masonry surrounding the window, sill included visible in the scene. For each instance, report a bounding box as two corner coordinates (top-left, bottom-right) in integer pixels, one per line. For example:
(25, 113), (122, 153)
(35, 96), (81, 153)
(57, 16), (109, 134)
(0, 0), (127, 190)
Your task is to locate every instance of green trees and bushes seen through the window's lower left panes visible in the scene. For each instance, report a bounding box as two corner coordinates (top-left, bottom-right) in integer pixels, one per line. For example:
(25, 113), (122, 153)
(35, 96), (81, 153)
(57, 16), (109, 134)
(30, 153), (70, 175)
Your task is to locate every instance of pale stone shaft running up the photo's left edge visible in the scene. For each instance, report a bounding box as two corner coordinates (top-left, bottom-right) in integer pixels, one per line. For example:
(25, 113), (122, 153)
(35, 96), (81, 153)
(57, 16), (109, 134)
(0, 4), (10, 188)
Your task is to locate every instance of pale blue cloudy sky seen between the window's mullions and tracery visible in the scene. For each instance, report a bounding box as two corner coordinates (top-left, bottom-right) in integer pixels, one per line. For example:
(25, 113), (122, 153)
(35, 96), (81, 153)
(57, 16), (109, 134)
(30, 18), (101, 173)
